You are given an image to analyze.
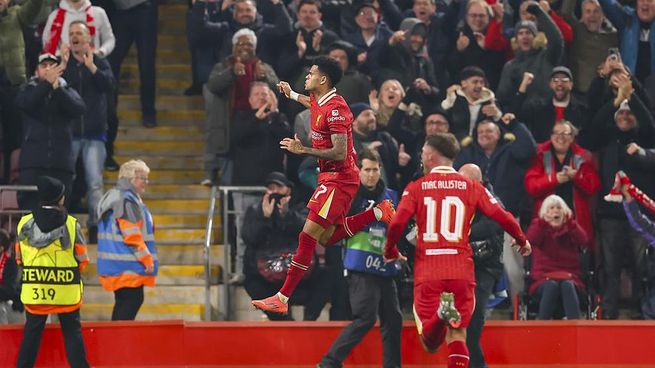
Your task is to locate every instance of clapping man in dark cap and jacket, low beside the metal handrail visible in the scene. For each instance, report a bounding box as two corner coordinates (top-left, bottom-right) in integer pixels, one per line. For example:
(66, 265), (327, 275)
(242, 172), (329, 320)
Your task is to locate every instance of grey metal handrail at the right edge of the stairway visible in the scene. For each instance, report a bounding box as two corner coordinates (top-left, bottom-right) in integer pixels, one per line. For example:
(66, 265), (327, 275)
(204, 185), (266, 321)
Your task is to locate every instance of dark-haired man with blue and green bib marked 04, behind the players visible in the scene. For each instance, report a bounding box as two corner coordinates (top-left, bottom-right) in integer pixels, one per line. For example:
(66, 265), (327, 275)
(318, 150), (402, 368)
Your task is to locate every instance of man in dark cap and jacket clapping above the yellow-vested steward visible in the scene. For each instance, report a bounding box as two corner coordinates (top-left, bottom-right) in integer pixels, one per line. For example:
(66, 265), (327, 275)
(16, 54), (86, 210)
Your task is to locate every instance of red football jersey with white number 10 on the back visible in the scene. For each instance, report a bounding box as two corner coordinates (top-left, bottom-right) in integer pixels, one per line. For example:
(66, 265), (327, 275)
(387, 166), (525, 284)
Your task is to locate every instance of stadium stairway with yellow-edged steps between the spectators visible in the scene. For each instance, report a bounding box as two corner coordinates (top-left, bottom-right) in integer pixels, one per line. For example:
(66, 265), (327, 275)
(75, 2), (223, 321)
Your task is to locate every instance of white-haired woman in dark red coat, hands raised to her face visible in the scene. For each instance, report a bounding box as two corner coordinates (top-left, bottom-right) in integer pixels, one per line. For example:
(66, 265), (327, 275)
(527, 194), (587, 320)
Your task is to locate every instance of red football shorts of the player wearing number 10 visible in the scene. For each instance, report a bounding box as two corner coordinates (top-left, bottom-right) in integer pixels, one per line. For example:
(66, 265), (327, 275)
(414, 280), (475, 334)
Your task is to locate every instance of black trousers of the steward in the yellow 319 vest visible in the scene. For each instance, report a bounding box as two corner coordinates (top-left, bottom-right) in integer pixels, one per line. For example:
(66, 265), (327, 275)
(16, 309), (89, 368)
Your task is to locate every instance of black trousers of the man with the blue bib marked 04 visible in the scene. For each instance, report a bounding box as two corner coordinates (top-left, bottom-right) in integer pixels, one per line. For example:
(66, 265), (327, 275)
(320, 272), (403, 368)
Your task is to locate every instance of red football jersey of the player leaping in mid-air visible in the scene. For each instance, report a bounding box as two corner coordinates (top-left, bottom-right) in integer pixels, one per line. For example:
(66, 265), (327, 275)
(309, 88), (357, 174)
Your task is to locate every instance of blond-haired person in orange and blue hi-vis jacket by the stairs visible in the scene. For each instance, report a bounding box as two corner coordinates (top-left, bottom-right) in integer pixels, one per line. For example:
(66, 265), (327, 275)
(98, 160), (159, 321)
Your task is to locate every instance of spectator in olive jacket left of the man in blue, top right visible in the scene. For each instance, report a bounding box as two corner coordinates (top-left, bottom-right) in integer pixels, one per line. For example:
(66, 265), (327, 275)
(560, 0), (619, 94)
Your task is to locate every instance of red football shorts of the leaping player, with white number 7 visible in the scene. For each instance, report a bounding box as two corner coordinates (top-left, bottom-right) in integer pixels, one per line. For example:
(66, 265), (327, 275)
(307, 171), (359, 227)
